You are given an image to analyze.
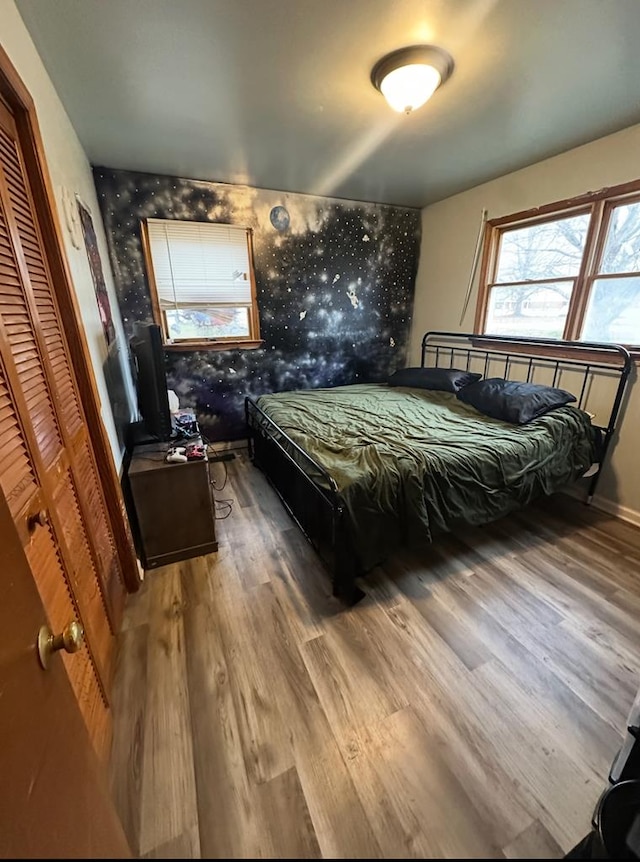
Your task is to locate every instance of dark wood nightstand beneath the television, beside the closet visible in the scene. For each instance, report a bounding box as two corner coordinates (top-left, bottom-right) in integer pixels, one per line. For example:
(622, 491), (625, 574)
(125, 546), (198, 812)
(127, 443), (218, 569)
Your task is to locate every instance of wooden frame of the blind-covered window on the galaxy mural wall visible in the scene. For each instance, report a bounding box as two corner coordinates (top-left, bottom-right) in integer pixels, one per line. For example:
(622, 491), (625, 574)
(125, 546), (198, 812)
(140, 217), (263, 351)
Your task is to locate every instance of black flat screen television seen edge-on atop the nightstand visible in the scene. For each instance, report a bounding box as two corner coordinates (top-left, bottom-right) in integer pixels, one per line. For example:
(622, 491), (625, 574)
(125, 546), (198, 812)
(129, 323), (173, 442)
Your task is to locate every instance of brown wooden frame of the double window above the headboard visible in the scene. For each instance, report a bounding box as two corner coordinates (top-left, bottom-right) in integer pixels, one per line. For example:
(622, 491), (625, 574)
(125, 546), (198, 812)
(473, 180), (640, 358)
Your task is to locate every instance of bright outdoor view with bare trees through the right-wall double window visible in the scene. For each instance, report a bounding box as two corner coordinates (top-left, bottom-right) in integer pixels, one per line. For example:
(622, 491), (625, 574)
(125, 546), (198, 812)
(484, 194), (640, 345)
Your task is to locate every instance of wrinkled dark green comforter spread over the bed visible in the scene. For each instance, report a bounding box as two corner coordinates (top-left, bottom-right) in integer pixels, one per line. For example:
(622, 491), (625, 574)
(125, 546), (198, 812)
(258, 384), (595, 570)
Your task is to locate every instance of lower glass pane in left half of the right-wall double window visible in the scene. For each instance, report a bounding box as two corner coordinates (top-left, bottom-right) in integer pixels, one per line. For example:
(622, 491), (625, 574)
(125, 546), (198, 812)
(484, 282), (573, 338)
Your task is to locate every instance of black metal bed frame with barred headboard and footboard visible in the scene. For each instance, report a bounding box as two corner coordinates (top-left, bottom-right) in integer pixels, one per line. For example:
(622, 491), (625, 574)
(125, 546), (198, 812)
(245, 331), (632, 604)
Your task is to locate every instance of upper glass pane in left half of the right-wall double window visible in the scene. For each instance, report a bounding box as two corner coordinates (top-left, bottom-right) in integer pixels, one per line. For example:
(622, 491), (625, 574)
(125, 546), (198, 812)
(496, 213), (590, 283)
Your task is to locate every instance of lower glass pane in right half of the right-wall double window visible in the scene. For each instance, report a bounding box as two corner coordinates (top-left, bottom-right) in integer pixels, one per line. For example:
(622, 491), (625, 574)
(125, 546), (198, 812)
(581, 277), (640, 344)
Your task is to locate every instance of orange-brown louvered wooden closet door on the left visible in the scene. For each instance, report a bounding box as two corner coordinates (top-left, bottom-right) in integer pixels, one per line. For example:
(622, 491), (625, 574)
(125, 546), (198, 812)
(0, 102), (124, 756)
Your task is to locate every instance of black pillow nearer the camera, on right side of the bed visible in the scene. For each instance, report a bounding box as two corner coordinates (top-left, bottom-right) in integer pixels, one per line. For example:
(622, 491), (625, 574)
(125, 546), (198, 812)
(457, 377), (576, 425)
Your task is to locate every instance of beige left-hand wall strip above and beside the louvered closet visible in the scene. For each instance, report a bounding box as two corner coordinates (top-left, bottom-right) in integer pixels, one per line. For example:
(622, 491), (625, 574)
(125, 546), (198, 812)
(0, 0), (133, 467)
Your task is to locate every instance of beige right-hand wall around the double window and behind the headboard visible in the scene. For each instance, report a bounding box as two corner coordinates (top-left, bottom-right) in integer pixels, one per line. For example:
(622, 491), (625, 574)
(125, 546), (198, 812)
(410, 125), (640, 523)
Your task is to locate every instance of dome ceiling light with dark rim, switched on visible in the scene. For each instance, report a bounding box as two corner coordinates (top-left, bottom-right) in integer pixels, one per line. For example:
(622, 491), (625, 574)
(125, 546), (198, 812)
(371, 45), (454, 114)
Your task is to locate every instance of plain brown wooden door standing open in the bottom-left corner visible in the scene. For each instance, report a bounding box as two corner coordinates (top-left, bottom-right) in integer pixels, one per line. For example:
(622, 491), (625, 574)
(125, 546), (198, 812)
(0, 486), (130, 859)
